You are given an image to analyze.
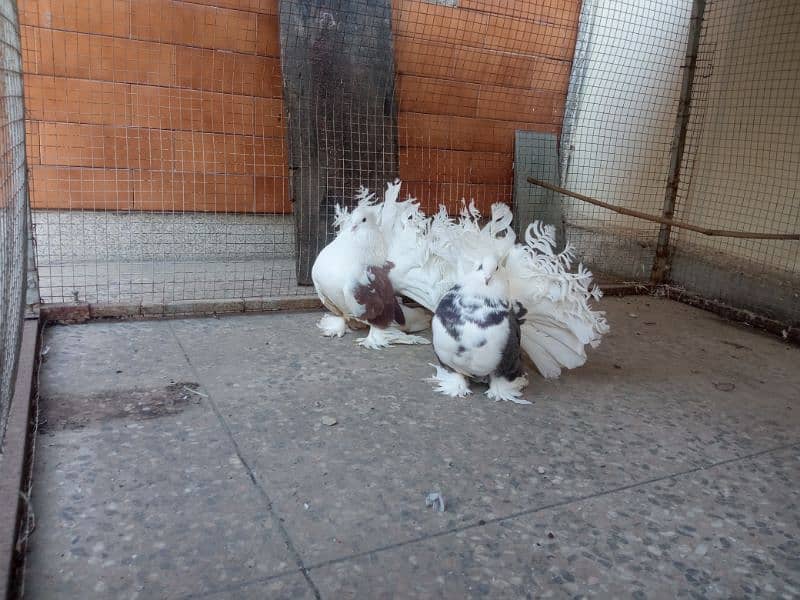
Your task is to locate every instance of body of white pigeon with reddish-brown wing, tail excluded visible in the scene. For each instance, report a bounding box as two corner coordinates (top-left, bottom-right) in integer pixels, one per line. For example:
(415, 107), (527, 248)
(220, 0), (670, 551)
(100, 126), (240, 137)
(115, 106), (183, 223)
(311, 183), (429, 349)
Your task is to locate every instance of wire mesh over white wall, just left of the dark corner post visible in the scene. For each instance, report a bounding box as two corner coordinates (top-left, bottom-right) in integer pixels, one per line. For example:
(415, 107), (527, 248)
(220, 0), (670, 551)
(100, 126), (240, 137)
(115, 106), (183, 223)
(544, 0), (691, 281)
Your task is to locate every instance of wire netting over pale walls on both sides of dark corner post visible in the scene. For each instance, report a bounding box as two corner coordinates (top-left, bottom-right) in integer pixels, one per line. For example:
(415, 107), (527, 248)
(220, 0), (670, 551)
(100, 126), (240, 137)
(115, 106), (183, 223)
(523, 0), (800, 322)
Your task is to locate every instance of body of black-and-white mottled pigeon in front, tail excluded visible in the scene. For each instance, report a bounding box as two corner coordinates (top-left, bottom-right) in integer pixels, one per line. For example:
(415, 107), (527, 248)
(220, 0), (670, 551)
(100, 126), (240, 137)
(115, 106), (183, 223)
(431, 257), (530, 404)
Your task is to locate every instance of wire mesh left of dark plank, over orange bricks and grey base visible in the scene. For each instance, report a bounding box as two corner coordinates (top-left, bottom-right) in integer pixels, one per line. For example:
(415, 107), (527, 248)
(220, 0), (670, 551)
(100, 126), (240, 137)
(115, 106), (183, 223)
(21, 0), (302, 305)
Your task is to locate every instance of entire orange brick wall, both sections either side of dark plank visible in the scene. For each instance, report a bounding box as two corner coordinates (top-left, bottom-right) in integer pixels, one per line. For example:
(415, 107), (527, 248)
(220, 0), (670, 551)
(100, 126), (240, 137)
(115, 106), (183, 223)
(20, 0), (579, 212)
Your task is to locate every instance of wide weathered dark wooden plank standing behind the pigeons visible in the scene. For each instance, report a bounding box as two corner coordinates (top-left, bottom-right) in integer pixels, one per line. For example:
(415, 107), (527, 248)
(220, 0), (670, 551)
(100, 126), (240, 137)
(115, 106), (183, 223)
(280, 0), (398, 285)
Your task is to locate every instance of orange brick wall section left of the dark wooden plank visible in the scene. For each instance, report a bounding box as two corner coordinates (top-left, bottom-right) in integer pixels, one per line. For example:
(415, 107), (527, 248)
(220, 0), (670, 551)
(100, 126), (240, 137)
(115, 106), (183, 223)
(20, 0), (291, 212)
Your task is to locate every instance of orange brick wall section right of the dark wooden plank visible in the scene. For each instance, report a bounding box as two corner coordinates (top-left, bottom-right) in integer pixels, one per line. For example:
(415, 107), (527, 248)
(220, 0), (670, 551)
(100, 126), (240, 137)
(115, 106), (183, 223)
(393, 0), (580, 211)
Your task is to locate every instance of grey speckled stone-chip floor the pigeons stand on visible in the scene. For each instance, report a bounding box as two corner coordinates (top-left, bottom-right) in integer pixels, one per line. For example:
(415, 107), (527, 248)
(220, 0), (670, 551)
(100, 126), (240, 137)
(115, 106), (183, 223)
(21, 297), (800, 599)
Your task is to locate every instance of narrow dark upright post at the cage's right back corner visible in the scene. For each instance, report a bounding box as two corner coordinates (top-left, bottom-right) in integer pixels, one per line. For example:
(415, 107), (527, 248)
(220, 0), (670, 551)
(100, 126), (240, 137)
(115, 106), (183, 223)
(650, 0), (706, 284)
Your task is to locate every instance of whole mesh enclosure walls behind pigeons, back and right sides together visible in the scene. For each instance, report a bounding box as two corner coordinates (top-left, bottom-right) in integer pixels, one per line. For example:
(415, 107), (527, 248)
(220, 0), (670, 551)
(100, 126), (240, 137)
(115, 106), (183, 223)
(4, 0), (800, 324)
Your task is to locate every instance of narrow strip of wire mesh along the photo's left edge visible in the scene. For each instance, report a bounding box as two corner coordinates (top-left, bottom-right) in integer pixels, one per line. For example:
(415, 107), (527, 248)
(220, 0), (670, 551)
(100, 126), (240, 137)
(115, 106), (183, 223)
(0, 0), (27, 446)
